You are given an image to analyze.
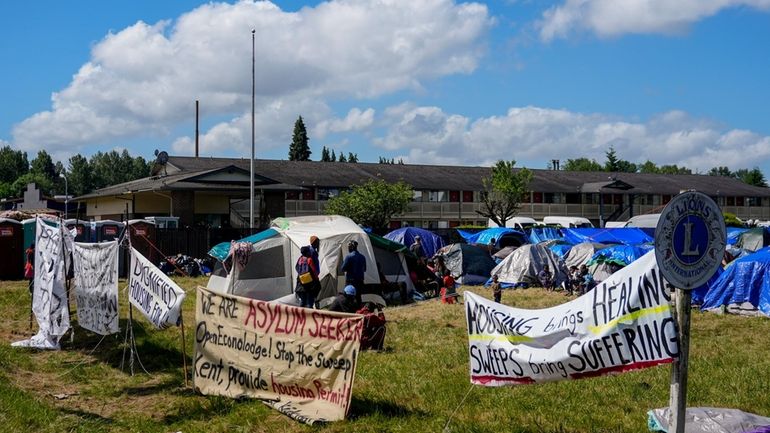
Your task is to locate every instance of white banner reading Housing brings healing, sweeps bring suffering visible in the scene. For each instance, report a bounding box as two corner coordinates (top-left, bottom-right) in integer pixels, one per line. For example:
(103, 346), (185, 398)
(465, 251), (679, 386)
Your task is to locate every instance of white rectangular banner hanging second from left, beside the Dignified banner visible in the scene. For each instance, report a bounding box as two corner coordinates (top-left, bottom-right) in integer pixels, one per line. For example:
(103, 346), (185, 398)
(73, 241), (119, 335)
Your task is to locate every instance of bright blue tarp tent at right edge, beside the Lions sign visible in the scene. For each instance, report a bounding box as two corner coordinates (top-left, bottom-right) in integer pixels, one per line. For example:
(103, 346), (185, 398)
(702, 247), (770, 316)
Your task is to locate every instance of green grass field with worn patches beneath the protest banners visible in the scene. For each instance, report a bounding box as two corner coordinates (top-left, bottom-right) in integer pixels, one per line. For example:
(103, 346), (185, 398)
(0, 279), (770, 433)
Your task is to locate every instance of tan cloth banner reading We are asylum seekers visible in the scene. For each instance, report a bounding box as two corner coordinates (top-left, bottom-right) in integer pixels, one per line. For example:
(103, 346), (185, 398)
(193, 287), (364, 424)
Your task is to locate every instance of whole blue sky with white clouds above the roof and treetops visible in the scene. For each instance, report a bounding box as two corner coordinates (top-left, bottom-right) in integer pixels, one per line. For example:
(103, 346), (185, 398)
(0, 0), (770, 176)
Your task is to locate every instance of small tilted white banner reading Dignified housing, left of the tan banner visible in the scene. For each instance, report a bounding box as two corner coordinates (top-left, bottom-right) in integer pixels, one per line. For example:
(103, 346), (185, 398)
(128, 247), (185, 329)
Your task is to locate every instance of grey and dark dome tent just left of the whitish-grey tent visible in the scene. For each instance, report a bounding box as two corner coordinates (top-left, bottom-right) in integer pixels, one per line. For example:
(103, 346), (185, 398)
(436, 243), (495, 284)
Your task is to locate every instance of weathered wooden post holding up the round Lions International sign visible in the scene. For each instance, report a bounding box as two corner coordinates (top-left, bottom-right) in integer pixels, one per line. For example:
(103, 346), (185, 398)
(668, 289), (692, 433)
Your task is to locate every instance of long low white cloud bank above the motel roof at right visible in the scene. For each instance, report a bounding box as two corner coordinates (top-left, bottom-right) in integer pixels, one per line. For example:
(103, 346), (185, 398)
(375, 104), (770, 172)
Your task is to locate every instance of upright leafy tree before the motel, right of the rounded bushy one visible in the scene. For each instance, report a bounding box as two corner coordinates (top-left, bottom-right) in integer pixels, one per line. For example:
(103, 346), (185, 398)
(476, 160), (533, 227)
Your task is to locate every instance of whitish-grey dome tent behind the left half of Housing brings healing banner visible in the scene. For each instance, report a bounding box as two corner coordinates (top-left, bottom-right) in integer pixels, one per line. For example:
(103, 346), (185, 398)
(492, 243), (567, 286)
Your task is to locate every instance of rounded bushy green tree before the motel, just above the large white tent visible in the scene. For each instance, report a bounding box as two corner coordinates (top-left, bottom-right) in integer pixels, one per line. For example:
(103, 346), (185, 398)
(325, 179), (413, 229)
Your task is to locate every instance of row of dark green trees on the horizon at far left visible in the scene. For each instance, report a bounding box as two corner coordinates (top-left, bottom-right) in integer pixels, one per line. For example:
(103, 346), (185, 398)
(0, 146), (152, 198)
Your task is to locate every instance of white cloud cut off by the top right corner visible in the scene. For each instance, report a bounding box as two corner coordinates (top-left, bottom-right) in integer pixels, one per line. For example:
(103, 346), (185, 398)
(537, 0), (770, 41)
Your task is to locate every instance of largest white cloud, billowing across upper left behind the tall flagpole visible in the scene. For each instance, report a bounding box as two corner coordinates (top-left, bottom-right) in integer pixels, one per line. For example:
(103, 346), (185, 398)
(13, 0), (493, 156)
